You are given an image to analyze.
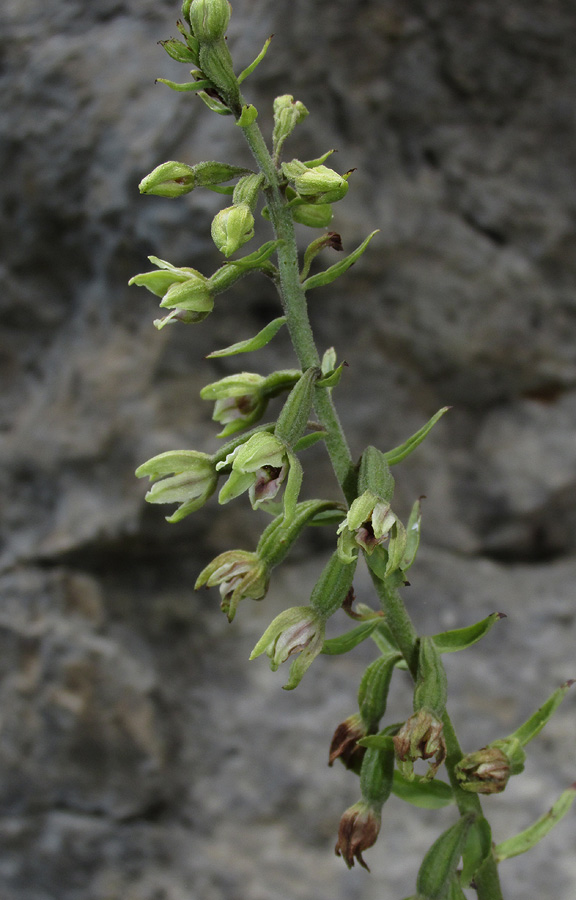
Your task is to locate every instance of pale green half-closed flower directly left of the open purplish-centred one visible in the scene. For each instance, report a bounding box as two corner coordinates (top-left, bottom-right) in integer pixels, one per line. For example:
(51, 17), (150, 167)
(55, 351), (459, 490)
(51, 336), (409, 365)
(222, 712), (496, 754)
(136, 450), (218, 522)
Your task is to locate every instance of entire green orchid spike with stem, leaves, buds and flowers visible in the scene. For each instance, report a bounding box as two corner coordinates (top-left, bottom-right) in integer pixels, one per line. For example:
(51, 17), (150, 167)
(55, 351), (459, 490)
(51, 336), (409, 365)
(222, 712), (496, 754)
(130, 0), (576, 900)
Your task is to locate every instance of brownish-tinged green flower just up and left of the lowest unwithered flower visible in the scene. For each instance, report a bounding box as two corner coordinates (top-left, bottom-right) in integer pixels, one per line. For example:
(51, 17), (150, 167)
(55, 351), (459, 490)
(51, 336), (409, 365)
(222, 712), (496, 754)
(194, 550), (270, 622)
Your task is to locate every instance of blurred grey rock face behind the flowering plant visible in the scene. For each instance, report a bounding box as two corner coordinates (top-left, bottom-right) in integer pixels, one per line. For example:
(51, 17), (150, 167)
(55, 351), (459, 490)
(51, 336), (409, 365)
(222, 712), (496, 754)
(0, 0), (576, 900)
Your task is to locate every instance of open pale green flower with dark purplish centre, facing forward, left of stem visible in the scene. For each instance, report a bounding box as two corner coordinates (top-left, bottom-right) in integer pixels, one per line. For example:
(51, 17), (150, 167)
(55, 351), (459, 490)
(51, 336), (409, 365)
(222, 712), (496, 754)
(216, 432), (289, 509)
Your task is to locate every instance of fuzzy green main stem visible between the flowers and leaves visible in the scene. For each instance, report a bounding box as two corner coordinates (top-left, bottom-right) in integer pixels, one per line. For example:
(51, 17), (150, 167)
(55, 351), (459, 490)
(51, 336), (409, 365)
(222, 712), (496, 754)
(236, 116), (502, 900)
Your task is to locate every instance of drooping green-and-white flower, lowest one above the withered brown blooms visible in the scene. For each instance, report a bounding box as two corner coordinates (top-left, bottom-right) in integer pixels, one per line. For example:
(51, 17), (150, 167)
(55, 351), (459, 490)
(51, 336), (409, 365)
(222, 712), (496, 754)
(250, 606), (325, 690)
